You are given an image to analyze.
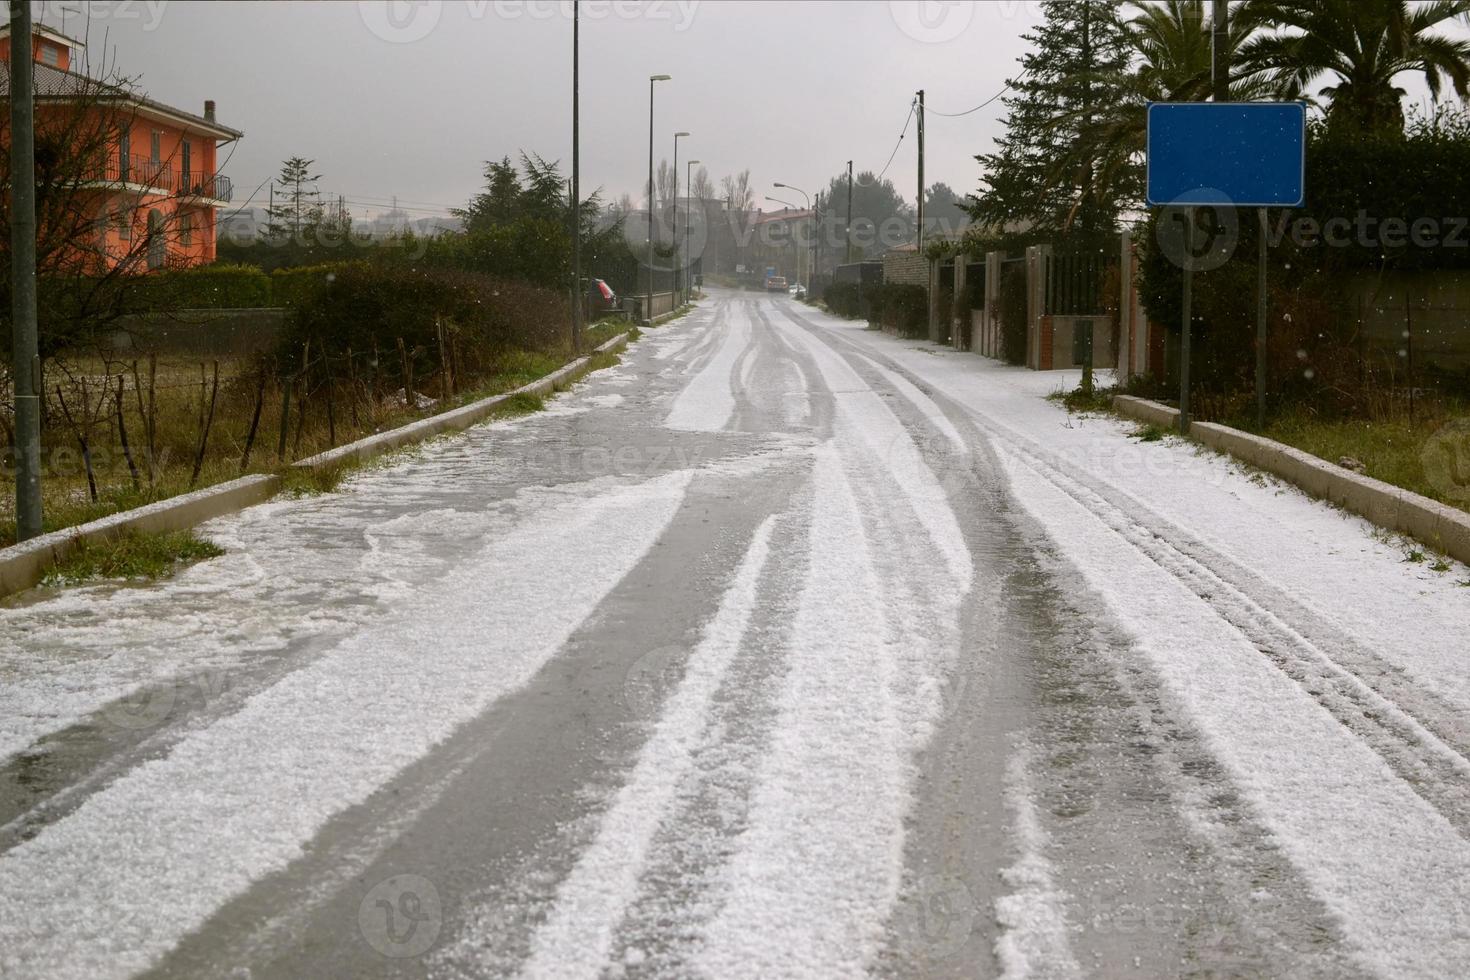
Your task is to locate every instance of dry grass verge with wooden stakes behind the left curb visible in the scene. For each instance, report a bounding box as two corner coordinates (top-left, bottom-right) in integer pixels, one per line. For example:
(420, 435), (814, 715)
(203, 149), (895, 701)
(0, 322), (626, 547)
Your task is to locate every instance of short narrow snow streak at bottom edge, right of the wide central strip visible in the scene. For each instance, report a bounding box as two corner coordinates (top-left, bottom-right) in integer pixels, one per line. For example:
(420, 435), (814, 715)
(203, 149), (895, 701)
(995, 746), (1082, 980)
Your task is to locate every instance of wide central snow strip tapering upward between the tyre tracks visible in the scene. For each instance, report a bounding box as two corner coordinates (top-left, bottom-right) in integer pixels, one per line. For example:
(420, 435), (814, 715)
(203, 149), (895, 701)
(692, 445), (908, 977)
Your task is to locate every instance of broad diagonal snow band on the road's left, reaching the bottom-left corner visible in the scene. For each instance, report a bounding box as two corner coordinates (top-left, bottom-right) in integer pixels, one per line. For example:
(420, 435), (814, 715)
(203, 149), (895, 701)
(0, 472), (691, 977)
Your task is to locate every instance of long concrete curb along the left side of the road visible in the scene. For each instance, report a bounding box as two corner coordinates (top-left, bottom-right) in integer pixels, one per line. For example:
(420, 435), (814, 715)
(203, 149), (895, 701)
(0, 334), (628, 597)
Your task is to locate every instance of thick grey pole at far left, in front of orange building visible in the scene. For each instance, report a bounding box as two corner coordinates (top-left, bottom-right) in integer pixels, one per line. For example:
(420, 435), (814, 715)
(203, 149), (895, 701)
(10, 0), (41, 541)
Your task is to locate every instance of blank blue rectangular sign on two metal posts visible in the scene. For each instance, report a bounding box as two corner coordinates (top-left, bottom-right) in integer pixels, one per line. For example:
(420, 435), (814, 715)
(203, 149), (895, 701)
(1148, 101), (1307, 207)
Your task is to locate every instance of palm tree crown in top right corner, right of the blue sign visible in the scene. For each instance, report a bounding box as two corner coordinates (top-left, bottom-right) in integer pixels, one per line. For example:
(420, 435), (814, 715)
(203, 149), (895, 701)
(1239, 0), (1470, 132)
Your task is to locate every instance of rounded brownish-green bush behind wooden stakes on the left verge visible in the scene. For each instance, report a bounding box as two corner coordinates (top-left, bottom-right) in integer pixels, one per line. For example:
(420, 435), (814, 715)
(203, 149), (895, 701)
(281, 263), (572, 378)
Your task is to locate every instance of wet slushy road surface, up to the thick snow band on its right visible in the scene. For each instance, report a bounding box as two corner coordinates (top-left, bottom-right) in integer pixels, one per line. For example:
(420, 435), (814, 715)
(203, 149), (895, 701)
(0, 292), (1440, 977)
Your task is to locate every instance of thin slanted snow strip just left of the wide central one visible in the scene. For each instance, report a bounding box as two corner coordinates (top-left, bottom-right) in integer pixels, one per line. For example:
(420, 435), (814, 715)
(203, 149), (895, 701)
(522, 517), (776, 977)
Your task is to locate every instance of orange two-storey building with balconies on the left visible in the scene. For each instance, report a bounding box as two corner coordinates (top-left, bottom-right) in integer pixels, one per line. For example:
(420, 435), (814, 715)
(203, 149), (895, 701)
(0, 25), (244, 272)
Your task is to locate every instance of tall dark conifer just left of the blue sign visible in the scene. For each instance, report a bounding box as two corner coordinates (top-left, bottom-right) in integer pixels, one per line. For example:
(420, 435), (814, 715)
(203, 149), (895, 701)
(969, 0), (1142, 235)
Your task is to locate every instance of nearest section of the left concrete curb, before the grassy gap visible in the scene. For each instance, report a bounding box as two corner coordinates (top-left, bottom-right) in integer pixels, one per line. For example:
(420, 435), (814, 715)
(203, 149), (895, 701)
(0, 473), (281, 597)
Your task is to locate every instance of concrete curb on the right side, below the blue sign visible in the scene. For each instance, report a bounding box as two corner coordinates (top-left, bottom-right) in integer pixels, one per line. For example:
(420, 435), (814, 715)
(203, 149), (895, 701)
(1113, 395), (1470, 564)
